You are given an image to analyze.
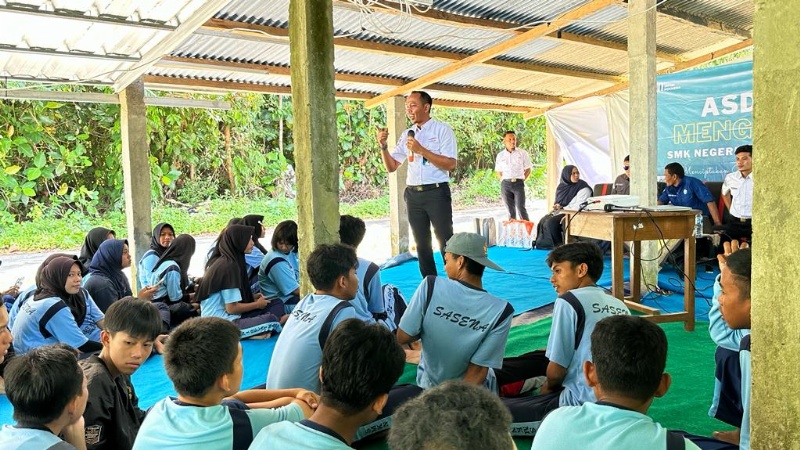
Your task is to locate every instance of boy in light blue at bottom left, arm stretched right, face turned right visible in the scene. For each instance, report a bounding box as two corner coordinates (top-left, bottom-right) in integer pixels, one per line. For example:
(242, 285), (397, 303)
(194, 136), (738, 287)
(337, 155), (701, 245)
(133, 317), (312, 450)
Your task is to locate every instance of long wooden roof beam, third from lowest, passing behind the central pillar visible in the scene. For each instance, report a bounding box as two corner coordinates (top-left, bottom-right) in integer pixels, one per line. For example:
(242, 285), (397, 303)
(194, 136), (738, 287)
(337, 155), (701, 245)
(203, 18), (623, 83)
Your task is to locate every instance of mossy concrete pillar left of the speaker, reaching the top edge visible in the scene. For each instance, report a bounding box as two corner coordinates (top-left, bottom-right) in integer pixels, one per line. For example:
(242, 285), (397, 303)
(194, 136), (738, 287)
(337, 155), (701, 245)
(289, 0), (339, 294)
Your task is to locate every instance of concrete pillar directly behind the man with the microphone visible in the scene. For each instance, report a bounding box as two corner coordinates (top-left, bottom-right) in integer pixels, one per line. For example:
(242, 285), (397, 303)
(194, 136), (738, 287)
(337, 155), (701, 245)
(386, 96), (408, 256)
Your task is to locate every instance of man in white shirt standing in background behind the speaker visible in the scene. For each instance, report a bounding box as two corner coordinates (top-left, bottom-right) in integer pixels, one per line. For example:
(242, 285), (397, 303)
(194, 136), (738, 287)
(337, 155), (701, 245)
(494, 131), (533, 220)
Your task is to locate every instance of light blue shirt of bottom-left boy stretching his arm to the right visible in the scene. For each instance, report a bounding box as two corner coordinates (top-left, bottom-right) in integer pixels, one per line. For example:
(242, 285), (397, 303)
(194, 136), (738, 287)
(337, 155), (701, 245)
(133, 397), (303, 450)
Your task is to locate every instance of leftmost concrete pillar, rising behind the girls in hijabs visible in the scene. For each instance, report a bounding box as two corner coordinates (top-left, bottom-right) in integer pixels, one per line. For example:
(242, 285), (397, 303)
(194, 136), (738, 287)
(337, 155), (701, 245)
(119, 78), (153, 294)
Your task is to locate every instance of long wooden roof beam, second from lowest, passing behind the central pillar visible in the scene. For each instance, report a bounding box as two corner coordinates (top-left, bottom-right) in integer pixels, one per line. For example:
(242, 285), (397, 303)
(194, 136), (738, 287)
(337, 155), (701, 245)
(156, 56), (568, 103)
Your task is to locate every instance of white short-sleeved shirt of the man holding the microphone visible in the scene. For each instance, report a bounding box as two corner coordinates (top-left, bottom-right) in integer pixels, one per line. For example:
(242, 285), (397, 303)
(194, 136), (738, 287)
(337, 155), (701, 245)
(392, 119), (458, 186)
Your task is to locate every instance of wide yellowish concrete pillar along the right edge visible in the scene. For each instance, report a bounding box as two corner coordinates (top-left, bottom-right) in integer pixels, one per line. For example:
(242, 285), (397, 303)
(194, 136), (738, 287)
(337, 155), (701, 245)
(750, 0), (800, 444)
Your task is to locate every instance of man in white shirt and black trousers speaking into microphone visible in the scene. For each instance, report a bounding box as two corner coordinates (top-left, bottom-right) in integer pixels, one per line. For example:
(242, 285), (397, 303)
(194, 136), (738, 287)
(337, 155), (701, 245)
(378, 91), (458, 278)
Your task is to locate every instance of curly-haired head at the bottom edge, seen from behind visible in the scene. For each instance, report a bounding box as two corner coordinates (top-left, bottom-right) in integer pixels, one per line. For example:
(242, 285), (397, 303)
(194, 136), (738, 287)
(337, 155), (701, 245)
(388, 381), (516, 450)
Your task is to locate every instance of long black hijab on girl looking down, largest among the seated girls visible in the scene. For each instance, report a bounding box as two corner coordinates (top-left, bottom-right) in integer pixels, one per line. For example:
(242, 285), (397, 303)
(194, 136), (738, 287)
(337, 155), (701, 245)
(196, 225), (253, 303)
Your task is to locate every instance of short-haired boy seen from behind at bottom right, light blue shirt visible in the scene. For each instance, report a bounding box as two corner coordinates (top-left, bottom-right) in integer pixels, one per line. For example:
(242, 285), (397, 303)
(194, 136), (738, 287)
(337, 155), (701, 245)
(531, 316), (698, 450)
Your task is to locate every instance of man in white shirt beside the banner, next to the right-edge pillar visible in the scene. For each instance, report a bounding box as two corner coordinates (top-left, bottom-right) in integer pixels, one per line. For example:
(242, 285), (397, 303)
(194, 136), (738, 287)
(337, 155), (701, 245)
(722, 145), (753, 242)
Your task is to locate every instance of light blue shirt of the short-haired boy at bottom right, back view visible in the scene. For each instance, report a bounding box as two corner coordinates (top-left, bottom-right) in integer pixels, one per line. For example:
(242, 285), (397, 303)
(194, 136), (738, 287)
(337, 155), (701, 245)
(531, 402), (699, 450)
